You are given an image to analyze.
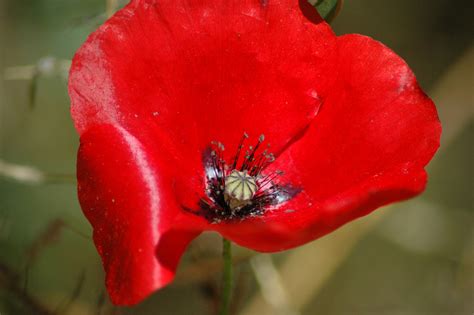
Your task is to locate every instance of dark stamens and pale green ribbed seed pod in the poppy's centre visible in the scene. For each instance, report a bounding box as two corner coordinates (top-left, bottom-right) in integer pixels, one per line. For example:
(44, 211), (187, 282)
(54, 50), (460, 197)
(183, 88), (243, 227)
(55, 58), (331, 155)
(200, 133), (299, 222)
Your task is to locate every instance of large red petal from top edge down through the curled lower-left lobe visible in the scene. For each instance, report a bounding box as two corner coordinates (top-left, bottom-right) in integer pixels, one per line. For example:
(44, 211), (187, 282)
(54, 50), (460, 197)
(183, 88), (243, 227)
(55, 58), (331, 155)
(69, 0), (335, 304)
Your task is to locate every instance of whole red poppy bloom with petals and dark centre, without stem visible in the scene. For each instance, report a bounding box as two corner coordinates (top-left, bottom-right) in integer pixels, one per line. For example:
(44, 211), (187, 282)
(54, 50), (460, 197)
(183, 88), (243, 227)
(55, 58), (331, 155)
(69, 0), (440, 305)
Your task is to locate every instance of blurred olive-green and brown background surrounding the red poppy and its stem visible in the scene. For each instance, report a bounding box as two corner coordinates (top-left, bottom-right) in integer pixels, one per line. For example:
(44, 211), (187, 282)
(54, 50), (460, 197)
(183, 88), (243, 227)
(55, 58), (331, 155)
(0, 0), (474, 315)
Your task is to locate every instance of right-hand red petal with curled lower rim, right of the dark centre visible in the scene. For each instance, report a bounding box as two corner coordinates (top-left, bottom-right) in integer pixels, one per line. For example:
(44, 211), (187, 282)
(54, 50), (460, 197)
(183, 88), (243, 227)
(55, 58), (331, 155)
(216, 35), (441, 251)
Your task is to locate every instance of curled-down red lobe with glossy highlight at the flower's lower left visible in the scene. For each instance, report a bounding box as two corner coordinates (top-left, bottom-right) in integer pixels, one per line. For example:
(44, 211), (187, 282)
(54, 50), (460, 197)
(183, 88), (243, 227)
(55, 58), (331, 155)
(77, 125), (204, 305)
